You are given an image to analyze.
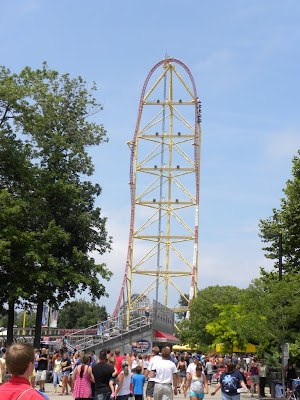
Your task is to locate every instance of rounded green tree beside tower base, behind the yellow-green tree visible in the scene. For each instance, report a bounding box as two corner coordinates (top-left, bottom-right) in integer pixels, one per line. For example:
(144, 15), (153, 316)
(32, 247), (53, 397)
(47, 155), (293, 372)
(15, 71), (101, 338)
(180, 285), (243, 351)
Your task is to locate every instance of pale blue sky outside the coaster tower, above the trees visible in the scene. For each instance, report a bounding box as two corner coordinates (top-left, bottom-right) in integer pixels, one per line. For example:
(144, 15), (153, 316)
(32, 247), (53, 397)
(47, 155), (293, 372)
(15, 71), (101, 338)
(0, 0), (300, 312)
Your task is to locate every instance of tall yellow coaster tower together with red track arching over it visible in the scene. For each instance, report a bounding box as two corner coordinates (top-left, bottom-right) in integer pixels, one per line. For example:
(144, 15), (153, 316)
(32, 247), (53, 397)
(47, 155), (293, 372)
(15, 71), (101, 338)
(112, 58), (201, 323)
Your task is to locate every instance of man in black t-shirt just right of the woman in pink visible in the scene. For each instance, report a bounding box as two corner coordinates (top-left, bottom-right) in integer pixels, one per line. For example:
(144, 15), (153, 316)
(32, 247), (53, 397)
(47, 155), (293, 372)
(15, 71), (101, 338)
(92, 350), (115, 400)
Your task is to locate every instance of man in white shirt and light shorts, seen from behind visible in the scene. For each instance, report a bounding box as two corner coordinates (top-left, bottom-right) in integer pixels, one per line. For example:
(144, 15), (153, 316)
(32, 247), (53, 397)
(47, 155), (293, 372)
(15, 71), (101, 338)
(151, 347), (177, 400)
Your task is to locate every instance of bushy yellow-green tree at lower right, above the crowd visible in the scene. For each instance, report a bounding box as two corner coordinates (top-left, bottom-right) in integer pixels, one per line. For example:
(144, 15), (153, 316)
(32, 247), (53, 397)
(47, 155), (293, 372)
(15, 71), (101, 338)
(206, 273), (300, 355)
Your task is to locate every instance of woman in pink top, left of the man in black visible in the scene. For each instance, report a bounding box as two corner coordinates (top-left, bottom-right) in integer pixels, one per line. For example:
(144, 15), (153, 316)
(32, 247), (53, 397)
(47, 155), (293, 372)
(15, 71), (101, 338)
(72, 354), (95, 400)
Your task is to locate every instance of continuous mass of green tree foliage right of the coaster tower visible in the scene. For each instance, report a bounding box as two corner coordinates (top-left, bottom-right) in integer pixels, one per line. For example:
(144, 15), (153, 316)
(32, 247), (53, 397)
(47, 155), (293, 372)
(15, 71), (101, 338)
(180, 151), (300, 360)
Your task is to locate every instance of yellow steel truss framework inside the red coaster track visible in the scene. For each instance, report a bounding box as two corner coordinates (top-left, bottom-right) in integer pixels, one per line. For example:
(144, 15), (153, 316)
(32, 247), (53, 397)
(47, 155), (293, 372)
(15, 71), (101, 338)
(126, 60), (201, 318)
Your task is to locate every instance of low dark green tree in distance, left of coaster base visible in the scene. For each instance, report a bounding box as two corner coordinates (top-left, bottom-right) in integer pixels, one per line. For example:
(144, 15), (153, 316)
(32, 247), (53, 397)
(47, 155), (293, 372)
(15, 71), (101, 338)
(57, 300), (108, 329)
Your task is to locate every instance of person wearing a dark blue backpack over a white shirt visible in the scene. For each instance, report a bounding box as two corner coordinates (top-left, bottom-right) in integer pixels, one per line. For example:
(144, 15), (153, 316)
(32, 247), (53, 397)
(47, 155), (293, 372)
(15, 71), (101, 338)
(211, 362), (247, 400)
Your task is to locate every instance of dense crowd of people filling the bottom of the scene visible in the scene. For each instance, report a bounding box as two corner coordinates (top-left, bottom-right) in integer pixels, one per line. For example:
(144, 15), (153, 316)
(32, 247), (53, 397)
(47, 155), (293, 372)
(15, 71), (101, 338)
(0, 343), (297, 400)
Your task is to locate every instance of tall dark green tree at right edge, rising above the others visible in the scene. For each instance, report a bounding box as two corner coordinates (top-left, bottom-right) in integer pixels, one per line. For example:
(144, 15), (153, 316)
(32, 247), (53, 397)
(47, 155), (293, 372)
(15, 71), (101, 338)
(260, 150), (300, 273)
